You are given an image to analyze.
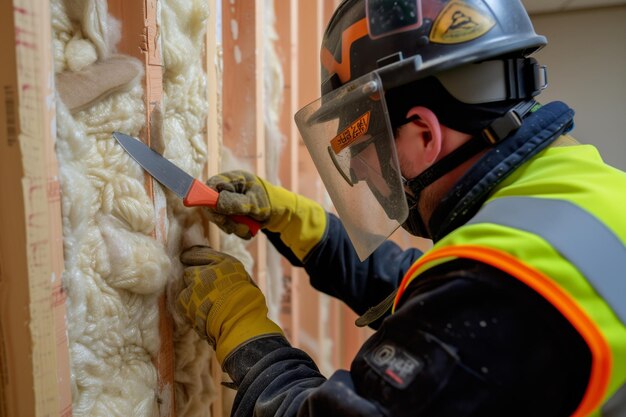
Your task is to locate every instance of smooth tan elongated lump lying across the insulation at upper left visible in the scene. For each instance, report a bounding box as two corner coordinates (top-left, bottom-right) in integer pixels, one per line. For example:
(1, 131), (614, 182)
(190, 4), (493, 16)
(55, 55), (143, 112)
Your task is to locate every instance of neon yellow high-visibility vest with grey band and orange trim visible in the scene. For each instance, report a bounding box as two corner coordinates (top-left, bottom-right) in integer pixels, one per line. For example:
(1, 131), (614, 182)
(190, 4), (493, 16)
(394, 141), (626, 417)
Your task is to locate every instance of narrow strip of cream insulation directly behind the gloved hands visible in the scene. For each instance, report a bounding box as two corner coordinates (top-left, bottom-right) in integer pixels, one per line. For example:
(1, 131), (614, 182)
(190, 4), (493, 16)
(157, 0), (216, 417)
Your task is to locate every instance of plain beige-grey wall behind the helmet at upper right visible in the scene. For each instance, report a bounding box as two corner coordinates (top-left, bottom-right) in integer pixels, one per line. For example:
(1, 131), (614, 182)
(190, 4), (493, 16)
(531, 6), (626, 171)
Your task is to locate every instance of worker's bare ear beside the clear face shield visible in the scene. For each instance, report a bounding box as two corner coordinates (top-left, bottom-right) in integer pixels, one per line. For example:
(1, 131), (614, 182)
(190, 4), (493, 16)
(406, 106), (443, 168)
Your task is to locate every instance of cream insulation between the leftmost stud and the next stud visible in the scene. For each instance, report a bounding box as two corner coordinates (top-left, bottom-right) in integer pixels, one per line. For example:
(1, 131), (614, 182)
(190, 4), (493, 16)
(51, 0), (170, 417)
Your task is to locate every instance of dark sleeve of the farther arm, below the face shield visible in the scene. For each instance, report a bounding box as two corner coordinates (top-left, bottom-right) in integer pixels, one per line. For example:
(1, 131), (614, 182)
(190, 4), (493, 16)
(265, 214), (422, 322)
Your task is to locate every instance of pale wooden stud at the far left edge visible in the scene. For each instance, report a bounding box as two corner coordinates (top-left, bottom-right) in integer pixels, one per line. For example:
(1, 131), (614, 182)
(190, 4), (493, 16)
(0, 0), (72, 417)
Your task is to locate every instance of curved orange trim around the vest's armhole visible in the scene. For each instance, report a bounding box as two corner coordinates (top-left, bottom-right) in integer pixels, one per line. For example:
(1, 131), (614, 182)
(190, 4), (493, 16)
(393, 245), (613, 417)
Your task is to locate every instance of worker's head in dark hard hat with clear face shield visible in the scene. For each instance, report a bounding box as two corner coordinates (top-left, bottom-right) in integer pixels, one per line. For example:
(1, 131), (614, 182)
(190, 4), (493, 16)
(296, 0), (546, 255)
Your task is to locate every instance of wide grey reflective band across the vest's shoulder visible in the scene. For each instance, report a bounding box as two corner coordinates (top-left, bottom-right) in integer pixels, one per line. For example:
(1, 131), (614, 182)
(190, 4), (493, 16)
(467, 197), (626, 324)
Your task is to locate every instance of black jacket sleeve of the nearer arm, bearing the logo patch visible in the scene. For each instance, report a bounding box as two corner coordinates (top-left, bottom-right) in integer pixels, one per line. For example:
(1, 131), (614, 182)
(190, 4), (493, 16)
(224, 260), (591, 417)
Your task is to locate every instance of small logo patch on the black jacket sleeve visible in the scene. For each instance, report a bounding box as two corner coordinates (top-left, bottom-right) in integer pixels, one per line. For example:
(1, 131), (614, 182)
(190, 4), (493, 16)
(365, 344), (424, 388)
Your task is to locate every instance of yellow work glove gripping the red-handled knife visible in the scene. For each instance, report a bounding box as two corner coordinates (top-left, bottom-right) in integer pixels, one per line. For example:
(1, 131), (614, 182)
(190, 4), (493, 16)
(207, 171), (326, 261)
